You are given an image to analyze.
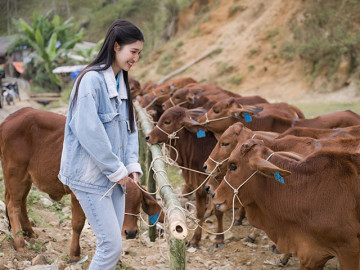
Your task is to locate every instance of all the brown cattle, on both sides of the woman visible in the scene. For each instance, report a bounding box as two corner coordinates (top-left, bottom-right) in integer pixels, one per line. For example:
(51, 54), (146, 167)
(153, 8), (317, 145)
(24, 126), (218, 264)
(0, 75), (360, 270)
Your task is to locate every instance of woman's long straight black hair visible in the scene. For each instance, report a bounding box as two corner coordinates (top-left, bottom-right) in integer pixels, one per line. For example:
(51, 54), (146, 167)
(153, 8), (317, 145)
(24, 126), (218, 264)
(71, 20), (145, 132)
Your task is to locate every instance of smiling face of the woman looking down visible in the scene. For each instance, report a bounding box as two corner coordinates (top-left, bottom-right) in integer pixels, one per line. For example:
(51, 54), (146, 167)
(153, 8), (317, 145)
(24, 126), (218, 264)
(112, 40), (144, 75)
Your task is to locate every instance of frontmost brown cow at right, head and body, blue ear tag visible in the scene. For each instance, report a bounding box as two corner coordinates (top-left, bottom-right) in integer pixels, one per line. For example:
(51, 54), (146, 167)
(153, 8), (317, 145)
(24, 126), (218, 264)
(214, 139), (360, 270)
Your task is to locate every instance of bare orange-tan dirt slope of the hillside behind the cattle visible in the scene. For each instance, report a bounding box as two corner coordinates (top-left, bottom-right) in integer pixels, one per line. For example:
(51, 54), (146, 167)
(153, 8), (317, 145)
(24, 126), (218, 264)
(133, 0), (360, 102)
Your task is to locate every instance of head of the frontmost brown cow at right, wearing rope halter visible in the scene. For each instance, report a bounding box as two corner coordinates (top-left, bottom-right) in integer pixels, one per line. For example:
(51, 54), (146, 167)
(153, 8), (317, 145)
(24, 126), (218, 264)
(213, 139), (291, 211)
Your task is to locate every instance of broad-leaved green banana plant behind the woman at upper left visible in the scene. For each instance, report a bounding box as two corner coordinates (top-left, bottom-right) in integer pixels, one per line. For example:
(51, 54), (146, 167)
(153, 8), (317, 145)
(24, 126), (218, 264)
(10, 12), (83, 90)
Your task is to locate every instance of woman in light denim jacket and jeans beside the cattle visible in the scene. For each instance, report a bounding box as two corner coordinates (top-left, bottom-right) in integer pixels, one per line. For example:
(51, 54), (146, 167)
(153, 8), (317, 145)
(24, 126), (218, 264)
(59, 20), (144, 270)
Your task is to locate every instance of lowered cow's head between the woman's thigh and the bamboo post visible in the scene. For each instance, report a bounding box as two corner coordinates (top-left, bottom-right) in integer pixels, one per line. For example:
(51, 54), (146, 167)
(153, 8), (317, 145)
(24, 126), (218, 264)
(122, 182), (164, 239)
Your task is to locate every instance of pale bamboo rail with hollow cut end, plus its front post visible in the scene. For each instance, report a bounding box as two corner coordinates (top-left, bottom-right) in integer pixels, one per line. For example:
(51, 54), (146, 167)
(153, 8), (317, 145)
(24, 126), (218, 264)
(134, 101), (188, 270)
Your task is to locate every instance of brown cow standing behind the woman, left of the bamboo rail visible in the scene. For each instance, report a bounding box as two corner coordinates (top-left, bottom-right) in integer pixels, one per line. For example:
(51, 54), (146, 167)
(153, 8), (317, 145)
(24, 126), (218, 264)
(0, 108), (163, 261)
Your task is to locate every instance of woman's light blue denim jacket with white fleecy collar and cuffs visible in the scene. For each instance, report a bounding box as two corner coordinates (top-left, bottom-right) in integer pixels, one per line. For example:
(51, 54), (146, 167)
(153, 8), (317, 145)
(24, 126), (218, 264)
(58, 67), (142, 195)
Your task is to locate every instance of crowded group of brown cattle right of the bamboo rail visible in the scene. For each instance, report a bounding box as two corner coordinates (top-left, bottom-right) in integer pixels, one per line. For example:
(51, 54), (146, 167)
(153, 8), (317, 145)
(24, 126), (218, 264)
(133, 78), (360, 270)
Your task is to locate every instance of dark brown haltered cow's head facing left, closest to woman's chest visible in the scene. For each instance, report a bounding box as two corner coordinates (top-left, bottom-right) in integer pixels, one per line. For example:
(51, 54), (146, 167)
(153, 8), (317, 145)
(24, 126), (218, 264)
(146, 106), (206, 144)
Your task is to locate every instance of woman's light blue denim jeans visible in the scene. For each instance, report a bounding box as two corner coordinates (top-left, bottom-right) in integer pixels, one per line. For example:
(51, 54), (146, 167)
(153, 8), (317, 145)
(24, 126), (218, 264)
(72, 185), (125, 270)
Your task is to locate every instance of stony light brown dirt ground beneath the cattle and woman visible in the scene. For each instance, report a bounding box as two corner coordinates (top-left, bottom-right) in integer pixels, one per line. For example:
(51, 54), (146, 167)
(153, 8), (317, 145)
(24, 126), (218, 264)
(0, 187), (339, 270)
